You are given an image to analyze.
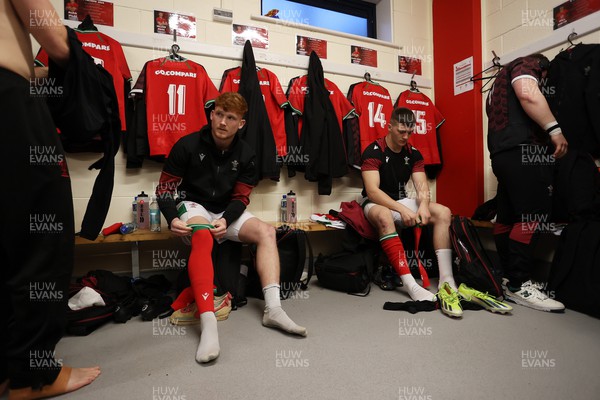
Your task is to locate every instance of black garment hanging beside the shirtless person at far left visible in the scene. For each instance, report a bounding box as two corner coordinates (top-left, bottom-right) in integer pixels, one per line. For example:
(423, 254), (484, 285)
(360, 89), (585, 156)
(46, 27), (121, 240)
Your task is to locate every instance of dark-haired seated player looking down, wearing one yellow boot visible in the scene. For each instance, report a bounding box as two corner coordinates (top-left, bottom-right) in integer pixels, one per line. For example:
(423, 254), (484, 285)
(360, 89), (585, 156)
(361, 108), (462, 317)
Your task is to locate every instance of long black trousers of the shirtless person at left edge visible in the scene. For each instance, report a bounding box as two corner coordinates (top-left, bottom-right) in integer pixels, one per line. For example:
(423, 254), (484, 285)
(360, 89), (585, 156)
(0, 68), (75, 388)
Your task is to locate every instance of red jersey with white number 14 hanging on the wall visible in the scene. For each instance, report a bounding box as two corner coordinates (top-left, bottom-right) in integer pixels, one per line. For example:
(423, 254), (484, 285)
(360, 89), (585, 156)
(348, 81), (394, 157)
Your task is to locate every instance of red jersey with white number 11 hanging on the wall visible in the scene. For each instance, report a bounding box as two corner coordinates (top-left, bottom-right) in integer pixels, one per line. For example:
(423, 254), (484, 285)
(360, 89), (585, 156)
(131, 58), (219, 156)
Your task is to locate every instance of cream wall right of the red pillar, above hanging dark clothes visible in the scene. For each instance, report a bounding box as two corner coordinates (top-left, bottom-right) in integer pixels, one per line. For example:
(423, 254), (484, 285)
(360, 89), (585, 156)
(476, 0), (600, 200)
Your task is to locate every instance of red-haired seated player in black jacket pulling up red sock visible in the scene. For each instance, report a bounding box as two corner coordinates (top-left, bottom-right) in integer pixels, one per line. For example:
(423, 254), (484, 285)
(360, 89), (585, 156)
(156, 92), (306, 363)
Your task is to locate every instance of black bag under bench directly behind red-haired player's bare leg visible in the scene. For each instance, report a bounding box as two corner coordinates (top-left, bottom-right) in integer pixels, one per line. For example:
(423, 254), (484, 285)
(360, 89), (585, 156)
(246, 225), (314, 299)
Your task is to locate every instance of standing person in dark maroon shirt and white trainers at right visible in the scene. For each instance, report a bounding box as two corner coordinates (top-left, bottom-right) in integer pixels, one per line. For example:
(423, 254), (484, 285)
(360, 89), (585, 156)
(486, 54), (568, 311)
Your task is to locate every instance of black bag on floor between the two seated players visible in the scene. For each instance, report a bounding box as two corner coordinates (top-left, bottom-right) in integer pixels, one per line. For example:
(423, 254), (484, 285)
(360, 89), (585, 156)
(315, 246), (376, 296)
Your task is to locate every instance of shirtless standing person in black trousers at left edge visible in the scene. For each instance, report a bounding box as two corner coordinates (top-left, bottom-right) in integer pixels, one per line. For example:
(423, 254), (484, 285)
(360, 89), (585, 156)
(0, 0), (100, 399)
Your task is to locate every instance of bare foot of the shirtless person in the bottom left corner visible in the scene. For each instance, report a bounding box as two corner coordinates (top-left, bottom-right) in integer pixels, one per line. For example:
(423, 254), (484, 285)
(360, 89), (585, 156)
(8, 366), (100, 400)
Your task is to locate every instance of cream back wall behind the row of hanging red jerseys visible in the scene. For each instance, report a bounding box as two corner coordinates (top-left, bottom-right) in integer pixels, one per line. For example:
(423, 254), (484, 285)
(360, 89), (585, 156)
(34, 0), (433, 231)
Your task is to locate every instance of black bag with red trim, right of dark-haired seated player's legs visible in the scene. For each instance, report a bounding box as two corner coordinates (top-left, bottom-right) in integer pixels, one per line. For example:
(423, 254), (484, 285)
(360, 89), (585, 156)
(450, 215), (504, 299)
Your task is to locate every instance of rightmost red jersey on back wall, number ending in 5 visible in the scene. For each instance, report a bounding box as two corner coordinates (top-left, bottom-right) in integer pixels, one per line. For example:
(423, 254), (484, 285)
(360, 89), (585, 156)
(394, 90), (446, 165)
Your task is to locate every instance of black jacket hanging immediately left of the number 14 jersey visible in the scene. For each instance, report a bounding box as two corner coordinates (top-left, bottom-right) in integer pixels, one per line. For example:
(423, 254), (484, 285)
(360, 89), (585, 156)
(300, 51), (348, 195)
